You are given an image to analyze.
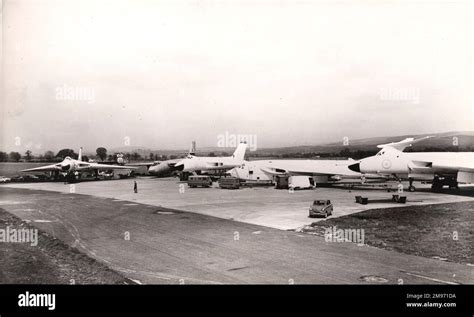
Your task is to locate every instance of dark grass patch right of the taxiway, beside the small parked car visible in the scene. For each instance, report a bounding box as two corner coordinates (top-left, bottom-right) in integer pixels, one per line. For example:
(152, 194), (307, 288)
(303, 202), (474, 264)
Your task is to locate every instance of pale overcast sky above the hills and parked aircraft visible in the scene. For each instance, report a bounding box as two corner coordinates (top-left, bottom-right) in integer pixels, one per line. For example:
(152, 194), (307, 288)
(1, 0), (474, 153)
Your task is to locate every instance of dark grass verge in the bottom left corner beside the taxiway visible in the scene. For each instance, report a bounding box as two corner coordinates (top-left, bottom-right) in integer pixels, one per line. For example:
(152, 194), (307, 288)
(0, 208), (130, 284)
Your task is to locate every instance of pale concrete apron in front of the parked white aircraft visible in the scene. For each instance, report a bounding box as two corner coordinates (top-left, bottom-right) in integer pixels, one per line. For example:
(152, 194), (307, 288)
(3, 177), (474, 230)
